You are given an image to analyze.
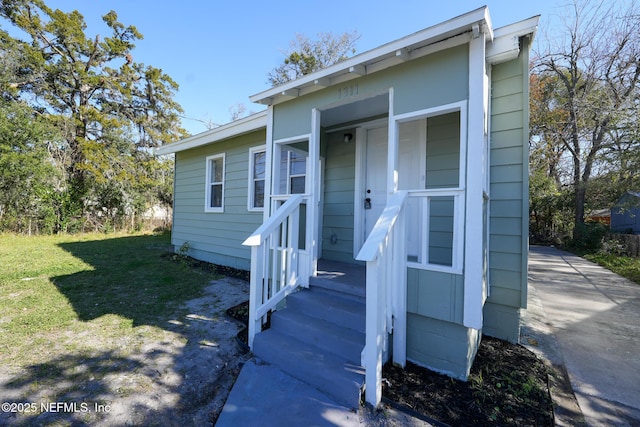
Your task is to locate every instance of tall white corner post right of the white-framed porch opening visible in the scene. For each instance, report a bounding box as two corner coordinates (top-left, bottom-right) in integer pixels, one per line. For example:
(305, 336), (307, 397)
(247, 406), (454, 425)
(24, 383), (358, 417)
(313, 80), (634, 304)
(463, 24), (490, 329)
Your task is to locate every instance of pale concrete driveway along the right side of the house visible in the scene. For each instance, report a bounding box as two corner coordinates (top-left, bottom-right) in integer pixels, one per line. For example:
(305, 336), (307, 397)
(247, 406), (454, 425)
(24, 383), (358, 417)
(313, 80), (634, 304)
(529, 246), (640, 426)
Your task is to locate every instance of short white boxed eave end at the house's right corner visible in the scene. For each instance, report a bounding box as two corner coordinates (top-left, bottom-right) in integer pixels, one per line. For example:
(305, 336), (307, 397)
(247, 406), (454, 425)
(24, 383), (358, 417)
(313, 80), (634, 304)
(486, 15), (540, 64)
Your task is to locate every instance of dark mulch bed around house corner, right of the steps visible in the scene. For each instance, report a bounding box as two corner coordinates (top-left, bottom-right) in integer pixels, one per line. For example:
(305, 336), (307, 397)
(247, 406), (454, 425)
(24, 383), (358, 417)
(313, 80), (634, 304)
(383, 336), (553, 426)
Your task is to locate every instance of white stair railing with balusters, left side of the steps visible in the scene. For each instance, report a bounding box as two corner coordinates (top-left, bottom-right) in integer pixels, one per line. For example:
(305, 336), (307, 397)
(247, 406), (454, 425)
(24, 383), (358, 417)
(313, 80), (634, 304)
(242, 194), (305, 348)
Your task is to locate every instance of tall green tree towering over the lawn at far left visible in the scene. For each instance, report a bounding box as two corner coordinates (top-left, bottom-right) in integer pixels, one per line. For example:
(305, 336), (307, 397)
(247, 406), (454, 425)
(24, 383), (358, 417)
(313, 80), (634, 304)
(0, 0), (186, 226)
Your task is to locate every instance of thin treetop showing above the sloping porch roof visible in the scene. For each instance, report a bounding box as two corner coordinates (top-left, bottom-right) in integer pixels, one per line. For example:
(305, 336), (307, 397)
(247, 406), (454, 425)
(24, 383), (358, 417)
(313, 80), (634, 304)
(267, 32), (360, 86)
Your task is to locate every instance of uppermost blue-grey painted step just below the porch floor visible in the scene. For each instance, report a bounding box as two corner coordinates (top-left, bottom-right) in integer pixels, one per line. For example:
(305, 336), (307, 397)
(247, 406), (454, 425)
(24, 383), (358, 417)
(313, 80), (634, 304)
(287, 287), (366, 333)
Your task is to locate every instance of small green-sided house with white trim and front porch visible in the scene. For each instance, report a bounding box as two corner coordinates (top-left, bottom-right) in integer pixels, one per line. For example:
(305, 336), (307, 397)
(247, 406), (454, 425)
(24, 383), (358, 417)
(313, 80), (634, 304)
(159, 7), (538, 405)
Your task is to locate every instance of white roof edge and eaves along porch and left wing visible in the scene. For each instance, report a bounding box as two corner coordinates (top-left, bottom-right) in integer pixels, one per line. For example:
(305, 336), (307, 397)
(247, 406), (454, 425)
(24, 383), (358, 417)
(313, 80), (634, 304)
(156, 6), (539, 155)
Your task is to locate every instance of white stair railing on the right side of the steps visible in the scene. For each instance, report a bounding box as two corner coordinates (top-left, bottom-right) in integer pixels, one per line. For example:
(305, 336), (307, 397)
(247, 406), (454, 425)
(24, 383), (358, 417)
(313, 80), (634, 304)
(356, 191), (408, 407)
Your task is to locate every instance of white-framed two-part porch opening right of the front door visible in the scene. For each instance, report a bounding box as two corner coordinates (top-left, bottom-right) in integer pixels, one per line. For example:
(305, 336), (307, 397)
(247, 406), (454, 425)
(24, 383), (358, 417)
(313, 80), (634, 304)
(397, 103), (466, 274)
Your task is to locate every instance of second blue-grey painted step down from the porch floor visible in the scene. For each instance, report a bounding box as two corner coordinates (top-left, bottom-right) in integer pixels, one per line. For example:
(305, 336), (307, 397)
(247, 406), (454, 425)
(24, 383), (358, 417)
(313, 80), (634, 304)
(271, 306), (365, 364)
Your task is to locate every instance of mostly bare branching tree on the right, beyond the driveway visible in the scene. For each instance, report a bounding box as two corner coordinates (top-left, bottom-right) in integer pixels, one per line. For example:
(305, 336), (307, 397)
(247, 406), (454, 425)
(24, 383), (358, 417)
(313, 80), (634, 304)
(534, 0), (640, 238)
